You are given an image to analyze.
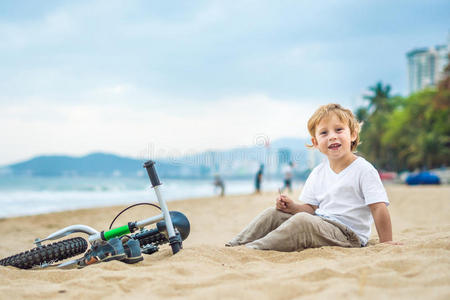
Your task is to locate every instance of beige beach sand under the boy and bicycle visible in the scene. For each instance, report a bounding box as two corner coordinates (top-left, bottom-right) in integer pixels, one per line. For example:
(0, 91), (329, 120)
(0, 185), (450, 300)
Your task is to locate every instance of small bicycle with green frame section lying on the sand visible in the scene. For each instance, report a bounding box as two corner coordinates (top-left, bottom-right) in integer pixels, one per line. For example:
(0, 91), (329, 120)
(0, 160), (190, 269)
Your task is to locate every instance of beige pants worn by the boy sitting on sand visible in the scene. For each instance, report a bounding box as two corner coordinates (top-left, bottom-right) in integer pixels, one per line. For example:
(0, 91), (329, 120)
(226, 208), (361, 252)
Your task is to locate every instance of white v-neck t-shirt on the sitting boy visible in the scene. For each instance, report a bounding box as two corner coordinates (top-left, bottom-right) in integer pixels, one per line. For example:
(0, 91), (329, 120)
(299, 157), (389, 245)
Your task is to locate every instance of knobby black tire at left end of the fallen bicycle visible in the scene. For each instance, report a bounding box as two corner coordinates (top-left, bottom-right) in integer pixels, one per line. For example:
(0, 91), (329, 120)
(0, 237), (88, 269)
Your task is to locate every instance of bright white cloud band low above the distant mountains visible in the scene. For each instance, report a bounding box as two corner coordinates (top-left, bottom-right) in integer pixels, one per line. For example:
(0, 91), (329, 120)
(0, 95), (317, 164)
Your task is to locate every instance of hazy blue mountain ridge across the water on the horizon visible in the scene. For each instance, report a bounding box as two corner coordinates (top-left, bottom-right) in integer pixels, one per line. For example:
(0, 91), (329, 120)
(0, 138), (320, 178)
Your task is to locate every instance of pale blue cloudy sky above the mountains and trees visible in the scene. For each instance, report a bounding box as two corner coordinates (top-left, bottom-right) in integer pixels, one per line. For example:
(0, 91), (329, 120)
(0, 0), (450, 165)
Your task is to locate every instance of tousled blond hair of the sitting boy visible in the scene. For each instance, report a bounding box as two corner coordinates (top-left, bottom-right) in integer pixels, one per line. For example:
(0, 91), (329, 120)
(306, 103), (362, 152)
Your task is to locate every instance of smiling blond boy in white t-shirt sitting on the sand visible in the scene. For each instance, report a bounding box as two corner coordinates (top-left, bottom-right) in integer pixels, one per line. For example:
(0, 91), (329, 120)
(226, 104), (396, 251)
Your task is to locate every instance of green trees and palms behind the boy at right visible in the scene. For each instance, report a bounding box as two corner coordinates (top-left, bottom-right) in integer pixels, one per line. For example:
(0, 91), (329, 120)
(355, 55), (450, 171)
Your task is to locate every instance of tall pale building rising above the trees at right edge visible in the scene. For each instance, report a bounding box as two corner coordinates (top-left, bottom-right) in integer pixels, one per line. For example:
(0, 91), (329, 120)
(406, 39), (449, 93)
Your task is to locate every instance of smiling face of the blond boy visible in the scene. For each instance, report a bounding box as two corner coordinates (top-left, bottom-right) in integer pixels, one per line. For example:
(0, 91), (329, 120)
(312, 113), (356, 160)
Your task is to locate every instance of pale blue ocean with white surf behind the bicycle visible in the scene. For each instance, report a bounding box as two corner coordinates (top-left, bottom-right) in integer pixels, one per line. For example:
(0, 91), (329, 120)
(0, 176), (298, 218)
